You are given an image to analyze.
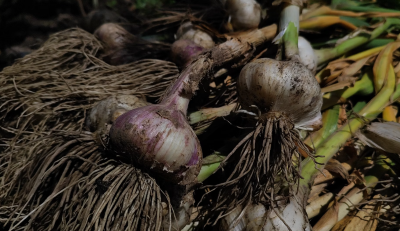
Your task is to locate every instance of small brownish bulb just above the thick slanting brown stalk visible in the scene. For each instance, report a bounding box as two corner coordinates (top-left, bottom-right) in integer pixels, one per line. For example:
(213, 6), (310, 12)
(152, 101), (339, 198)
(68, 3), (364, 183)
(176, 22), (215, 49)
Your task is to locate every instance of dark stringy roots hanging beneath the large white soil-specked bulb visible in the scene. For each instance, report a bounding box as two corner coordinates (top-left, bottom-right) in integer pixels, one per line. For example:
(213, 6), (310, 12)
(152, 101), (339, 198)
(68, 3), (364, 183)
(202, 112), (314, 223)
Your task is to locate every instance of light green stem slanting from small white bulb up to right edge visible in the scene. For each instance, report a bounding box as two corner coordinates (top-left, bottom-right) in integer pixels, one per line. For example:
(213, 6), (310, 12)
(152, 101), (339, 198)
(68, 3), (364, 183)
(315, 18), (400, 64)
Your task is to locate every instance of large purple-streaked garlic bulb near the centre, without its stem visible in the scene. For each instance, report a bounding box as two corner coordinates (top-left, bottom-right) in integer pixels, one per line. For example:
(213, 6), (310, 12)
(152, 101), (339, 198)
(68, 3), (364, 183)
(110, 104), (202, 184)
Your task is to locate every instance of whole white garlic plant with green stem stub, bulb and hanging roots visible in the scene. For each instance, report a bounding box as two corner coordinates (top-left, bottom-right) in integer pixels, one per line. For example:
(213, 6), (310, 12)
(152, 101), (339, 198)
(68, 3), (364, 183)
(206, 18), (322, 227)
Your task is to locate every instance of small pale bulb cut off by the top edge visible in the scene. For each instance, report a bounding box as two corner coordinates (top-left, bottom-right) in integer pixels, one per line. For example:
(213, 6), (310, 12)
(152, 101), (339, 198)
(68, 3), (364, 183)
(223, 0), (261, 30)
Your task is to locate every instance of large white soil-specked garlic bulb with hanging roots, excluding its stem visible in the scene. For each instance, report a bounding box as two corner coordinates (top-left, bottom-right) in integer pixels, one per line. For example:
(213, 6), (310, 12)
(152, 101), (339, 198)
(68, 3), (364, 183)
(222, 58), (322, 208)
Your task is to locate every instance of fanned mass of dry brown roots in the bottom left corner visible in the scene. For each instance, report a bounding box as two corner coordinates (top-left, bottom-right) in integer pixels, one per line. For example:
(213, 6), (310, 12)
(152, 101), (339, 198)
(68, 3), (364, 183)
(0, 132), (169, 230)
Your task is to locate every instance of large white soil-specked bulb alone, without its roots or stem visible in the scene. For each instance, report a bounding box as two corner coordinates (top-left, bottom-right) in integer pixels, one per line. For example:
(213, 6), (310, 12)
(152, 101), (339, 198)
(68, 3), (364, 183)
(237, 58), (322, 130)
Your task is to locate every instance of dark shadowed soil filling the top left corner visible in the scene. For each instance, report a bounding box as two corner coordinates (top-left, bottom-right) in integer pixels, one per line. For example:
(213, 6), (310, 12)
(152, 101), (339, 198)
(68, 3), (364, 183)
(0, 0), (198, 70)
